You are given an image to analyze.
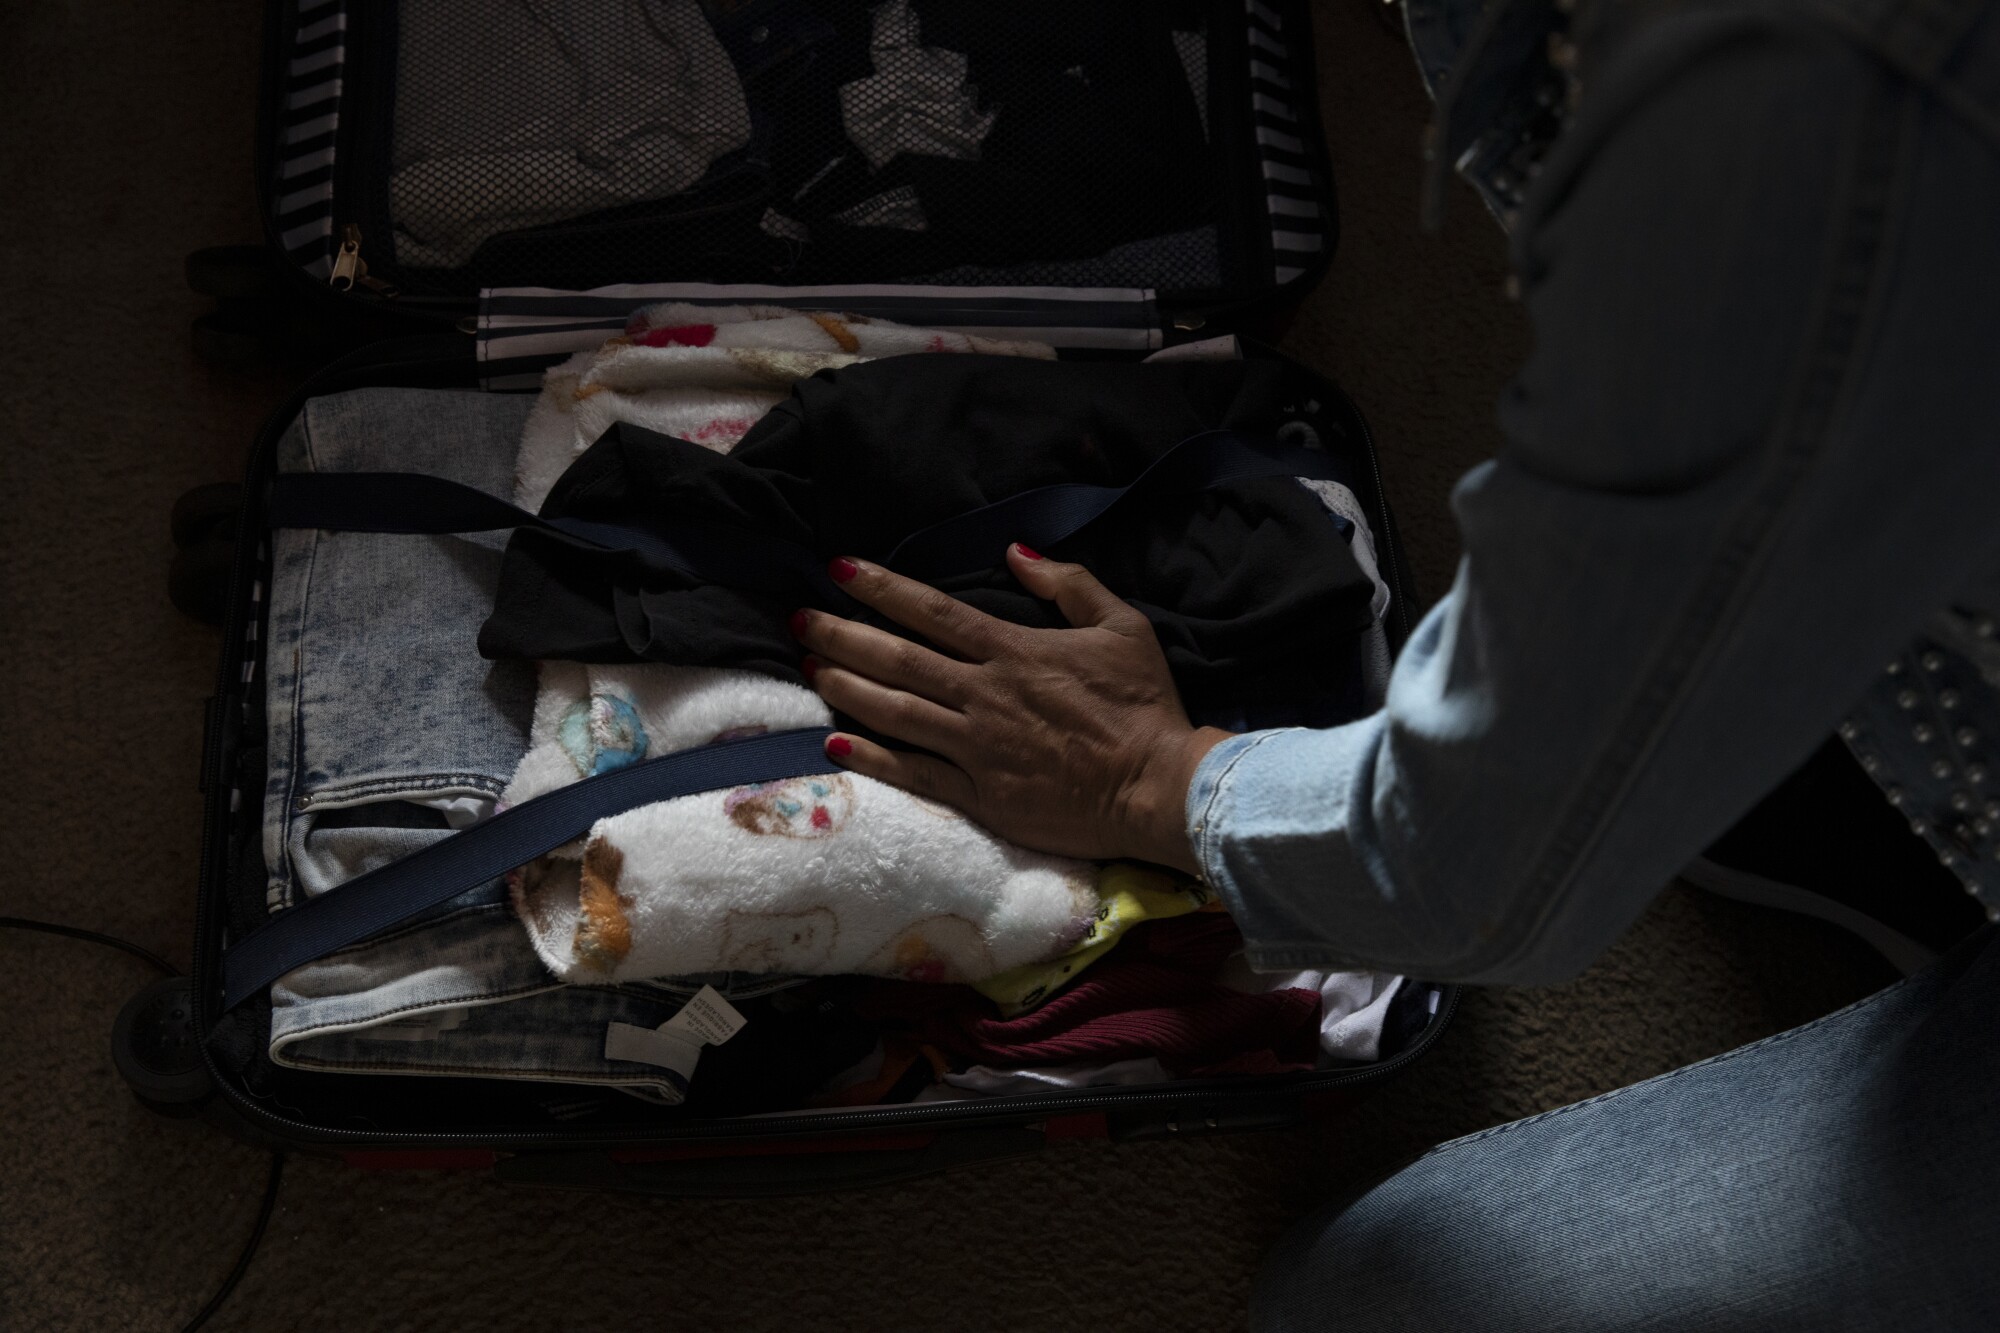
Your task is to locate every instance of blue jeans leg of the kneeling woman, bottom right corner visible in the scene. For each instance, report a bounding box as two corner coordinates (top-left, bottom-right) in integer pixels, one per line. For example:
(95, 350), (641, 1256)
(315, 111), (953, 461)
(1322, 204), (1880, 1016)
(1250, 927), (2000, 1333)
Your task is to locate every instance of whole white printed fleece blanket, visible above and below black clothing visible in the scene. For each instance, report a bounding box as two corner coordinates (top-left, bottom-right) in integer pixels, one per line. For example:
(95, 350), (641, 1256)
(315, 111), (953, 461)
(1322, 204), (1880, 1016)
(502, 304), (1098, 983)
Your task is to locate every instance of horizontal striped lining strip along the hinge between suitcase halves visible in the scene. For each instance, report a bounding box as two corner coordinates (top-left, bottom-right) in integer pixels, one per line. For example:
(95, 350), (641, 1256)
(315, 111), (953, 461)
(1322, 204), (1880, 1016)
(478, 282), (1162, 388)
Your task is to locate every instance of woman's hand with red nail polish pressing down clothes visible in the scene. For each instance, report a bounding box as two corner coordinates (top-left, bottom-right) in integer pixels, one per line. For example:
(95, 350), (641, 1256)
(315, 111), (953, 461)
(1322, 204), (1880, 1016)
(792, 544), (1228, 873)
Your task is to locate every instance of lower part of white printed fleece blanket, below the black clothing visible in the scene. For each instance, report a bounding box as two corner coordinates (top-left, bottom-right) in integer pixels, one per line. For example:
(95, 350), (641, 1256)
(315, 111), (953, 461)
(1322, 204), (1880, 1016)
(506, 662), (1098, 983)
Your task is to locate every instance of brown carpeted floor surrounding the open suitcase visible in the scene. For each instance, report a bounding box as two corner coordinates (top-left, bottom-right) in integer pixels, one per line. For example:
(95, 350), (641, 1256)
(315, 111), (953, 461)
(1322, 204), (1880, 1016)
(0, 0), (1888, 1333)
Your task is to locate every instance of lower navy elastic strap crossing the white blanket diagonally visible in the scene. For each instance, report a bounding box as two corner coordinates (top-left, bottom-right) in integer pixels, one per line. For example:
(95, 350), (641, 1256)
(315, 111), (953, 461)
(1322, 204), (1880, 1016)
(222, 727), (836, 1009)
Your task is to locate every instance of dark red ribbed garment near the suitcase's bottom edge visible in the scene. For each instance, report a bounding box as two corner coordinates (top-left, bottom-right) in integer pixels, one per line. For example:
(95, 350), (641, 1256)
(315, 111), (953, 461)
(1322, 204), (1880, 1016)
(854, 913), (1320, 1075)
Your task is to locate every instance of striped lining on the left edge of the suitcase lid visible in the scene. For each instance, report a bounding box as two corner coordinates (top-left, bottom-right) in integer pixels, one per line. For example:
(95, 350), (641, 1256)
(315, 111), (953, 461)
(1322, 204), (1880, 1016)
(272, 0), (348, 278)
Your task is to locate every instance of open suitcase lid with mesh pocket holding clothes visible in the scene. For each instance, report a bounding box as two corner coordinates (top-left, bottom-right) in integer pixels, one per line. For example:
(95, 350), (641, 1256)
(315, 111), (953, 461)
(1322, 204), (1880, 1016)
(258, 0), (1334, 312)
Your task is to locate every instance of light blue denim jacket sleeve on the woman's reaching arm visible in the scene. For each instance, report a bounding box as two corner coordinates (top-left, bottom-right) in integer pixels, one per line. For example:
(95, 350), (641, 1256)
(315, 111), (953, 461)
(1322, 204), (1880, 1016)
(1186, 20), (2000, 983)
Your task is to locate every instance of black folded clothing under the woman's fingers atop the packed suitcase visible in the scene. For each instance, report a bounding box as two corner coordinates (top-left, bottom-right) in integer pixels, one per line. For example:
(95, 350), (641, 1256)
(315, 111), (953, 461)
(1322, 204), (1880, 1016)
(480, 354), (1372, 725)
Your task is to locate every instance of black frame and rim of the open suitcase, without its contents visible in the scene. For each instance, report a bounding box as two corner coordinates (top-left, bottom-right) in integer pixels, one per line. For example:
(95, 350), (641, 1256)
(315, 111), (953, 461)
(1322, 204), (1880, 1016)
(141, 0), (1456, 1195)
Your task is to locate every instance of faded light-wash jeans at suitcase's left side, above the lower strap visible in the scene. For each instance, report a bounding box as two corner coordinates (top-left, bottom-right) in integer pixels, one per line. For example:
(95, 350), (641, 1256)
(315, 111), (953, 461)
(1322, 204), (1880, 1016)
(264, 388), (534, 909)
